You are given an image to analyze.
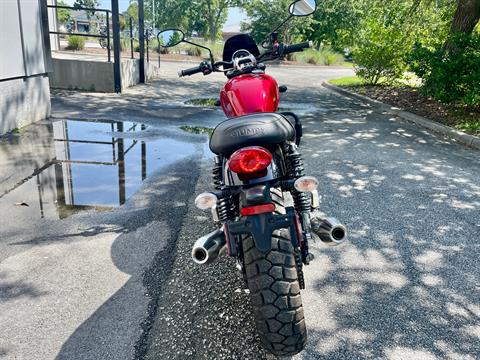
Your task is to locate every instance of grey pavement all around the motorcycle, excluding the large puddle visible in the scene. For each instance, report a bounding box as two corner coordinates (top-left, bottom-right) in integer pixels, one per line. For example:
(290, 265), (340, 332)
(0, 63), (480, 360)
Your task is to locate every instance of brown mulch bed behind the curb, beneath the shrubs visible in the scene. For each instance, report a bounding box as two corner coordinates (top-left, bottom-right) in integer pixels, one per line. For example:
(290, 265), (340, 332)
(345, 85), (480, 135)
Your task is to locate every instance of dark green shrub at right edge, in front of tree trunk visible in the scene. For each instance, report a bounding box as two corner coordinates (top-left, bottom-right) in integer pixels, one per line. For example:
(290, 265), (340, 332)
(410, 33), (480, 105)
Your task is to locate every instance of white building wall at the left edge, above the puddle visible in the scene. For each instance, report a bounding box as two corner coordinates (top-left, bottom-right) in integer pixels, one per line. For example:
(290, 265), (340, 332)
(0, 0), (51, 134)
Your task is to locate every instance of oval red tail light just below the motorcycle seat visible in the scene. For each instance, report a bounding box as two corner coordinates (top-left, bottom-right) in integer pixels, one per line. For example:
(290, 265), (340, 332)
(228, 146), (272, 174)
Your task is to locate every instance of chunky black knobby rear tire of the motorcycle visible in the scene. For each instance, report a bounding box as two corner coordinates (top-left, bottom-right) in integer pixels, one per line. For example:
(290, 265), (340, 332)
(243, 230), (307, 356)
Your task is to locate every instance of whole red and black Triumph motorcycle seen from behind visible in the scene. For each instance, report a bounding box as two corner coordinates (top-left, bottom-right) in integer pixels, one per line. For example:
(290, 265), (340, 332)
(158, 0), (347, 355)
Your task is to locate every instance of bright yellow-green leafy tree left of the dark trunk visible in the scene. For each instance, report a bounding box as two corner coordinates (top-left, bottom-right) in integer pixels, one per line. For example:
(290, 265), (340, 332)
(353, 0), (452, 84)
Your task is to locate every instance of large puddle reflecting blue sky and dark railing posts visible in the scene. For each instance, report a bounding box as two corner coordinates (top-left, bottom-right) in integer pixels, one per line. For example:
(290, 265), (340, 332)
(0, 120), (196, 219)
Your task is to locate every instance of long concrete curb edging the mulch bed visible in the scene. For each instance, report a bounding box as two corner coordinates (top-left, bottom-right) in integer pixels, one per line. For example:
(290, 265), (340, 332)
(322, 81), (480, 150)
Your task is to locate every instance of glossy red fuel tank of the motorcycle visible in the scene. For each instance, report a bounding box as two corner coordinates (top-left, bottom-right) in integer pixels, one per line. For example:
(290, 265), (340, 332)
(220, 74), (280, 118)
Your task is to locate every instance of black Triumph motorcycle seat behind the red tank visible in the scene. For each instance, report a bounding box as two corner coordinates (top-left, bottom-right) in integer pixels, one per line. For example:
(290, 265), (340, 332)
(210, 113), (295, 156)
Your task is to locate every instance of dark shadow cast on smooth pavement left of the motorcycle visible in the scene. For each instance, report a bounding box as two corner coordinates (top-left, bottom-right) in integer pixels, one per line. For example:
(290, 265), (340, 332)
(53, 160), (202, 359)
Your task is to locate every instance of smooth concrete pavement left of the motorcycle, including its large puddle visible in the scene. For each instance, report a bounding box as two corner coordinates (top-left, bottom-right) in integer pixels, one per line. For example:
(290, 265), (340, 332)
(0, 69), (215, 359)
